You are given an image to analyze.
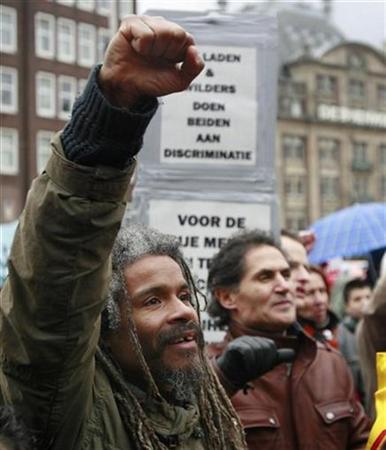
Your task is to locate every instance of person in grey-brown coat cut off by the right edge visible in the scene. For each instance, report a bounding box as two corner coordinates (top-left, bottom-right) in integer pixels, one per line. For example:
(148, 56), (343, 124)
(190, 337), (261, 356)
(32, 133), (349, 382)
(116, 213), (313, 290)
(356, 272), (386, 419)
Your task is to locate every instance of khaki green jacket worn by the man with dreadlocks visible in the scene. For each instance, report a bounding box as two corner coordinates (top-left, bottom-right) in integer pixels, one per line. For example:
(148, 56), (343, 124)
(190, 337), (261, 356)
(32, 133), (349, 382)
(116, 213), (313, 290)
(0, 135), (203, 450)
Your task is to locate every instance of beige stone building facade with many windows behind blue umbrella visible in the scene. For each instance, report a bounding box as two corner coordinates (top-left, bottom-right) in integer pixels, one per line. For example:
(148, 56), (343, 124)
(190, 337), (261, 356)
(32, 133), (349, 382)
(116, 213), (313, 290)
(276, 43), (386, 231)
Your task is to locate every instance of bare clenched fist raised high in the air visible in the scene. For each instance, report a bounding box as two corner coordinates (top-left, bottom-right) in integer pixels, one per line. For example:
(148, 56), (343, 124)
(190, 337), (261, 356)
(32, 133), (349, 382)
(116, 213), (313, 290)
(98, 15), (204, 107)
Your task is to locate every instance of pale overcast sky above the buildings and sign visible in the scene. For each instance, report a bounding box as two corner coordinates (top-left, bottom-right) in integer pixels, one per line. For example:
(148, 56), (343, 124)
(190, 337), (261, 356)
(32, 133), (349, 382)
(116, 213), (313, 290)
(137, 0), (386, 48)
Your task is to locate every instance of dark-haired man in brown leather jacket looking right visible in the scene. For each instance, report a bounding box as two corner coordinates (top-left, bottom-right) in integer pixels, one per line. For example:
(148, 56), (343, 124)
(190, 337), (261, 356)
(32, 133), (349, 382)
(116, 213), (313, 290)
(208, 231), (369, 450)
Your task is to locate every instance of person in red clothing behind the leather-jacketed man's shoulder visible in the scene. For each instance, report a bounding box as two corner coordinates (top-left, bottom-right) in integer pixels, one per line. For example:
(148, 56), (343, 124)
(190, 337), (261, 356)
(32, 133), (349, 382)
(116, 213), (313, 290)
(298, 266), (339, 348)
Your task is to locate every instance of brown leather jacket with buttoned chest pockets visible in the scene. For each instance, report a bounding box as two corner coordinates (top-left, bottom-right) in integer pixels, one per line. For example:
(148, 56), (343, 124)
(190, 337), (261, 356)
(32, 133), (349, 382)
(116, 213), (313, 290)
(208, 325), (369, 450)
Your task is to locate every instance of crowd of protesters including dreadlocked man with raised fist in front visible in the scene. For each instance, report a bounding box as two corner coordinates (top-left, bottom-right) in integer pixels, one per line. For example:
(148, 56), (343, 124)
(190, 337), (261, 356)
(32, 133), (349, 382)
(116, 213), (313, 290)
(0, 16), (386, 450)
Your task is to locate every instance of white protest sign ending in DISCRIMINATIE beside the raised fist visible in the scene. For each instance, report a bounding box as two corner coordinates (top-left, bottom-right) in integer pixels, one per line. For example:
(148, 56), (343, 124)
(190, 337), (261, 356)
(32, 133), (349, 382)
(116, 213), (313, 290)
(160, 45), (257, 166)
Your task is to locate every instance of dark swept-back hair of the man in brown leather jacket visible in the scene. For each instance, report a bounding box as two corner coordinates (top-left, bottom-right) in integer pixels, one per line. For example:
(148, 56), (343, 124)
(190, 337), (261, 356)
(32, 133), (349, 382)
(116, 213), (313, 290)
(207, 230), (282, 325)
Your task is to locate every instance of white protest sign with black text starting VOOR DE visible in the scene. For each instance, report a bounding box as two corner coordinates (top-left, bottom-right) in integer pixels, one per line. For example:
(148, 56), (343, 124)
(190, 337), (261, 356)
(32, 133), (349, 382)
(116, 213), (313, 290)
(149, 200), (271, 342)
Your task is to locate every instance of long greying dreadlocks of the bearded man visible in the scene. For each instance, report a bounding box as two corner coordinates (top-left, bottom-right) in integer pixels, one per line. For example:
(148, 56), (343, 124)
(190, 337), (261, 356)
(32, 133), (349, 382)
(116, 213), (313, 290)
(96, 225), (247, 450)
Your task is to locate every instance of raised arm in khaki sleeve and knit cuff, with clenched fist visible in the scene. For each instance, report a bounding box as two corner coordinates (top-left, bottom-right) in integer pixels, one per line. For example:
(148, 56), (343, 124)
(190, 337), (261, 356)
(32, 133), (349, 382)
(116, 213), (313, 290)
(0, 16), (203, 442)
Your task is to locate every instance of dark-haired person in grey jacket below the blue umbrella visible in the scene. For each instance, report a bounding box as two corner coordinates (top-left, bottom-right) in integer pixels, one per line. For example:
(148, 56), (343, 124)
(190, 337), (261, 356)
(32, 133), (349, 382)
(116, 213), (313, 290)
(337, 278), (371, 404)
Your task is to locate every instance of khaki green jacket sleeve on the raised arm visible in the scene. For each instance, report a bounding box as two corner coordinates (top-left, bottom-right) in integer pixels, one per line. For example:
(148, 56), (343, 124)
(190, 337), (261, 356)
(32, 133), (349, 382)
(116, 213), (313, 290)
(0, 137), (131, 428)
